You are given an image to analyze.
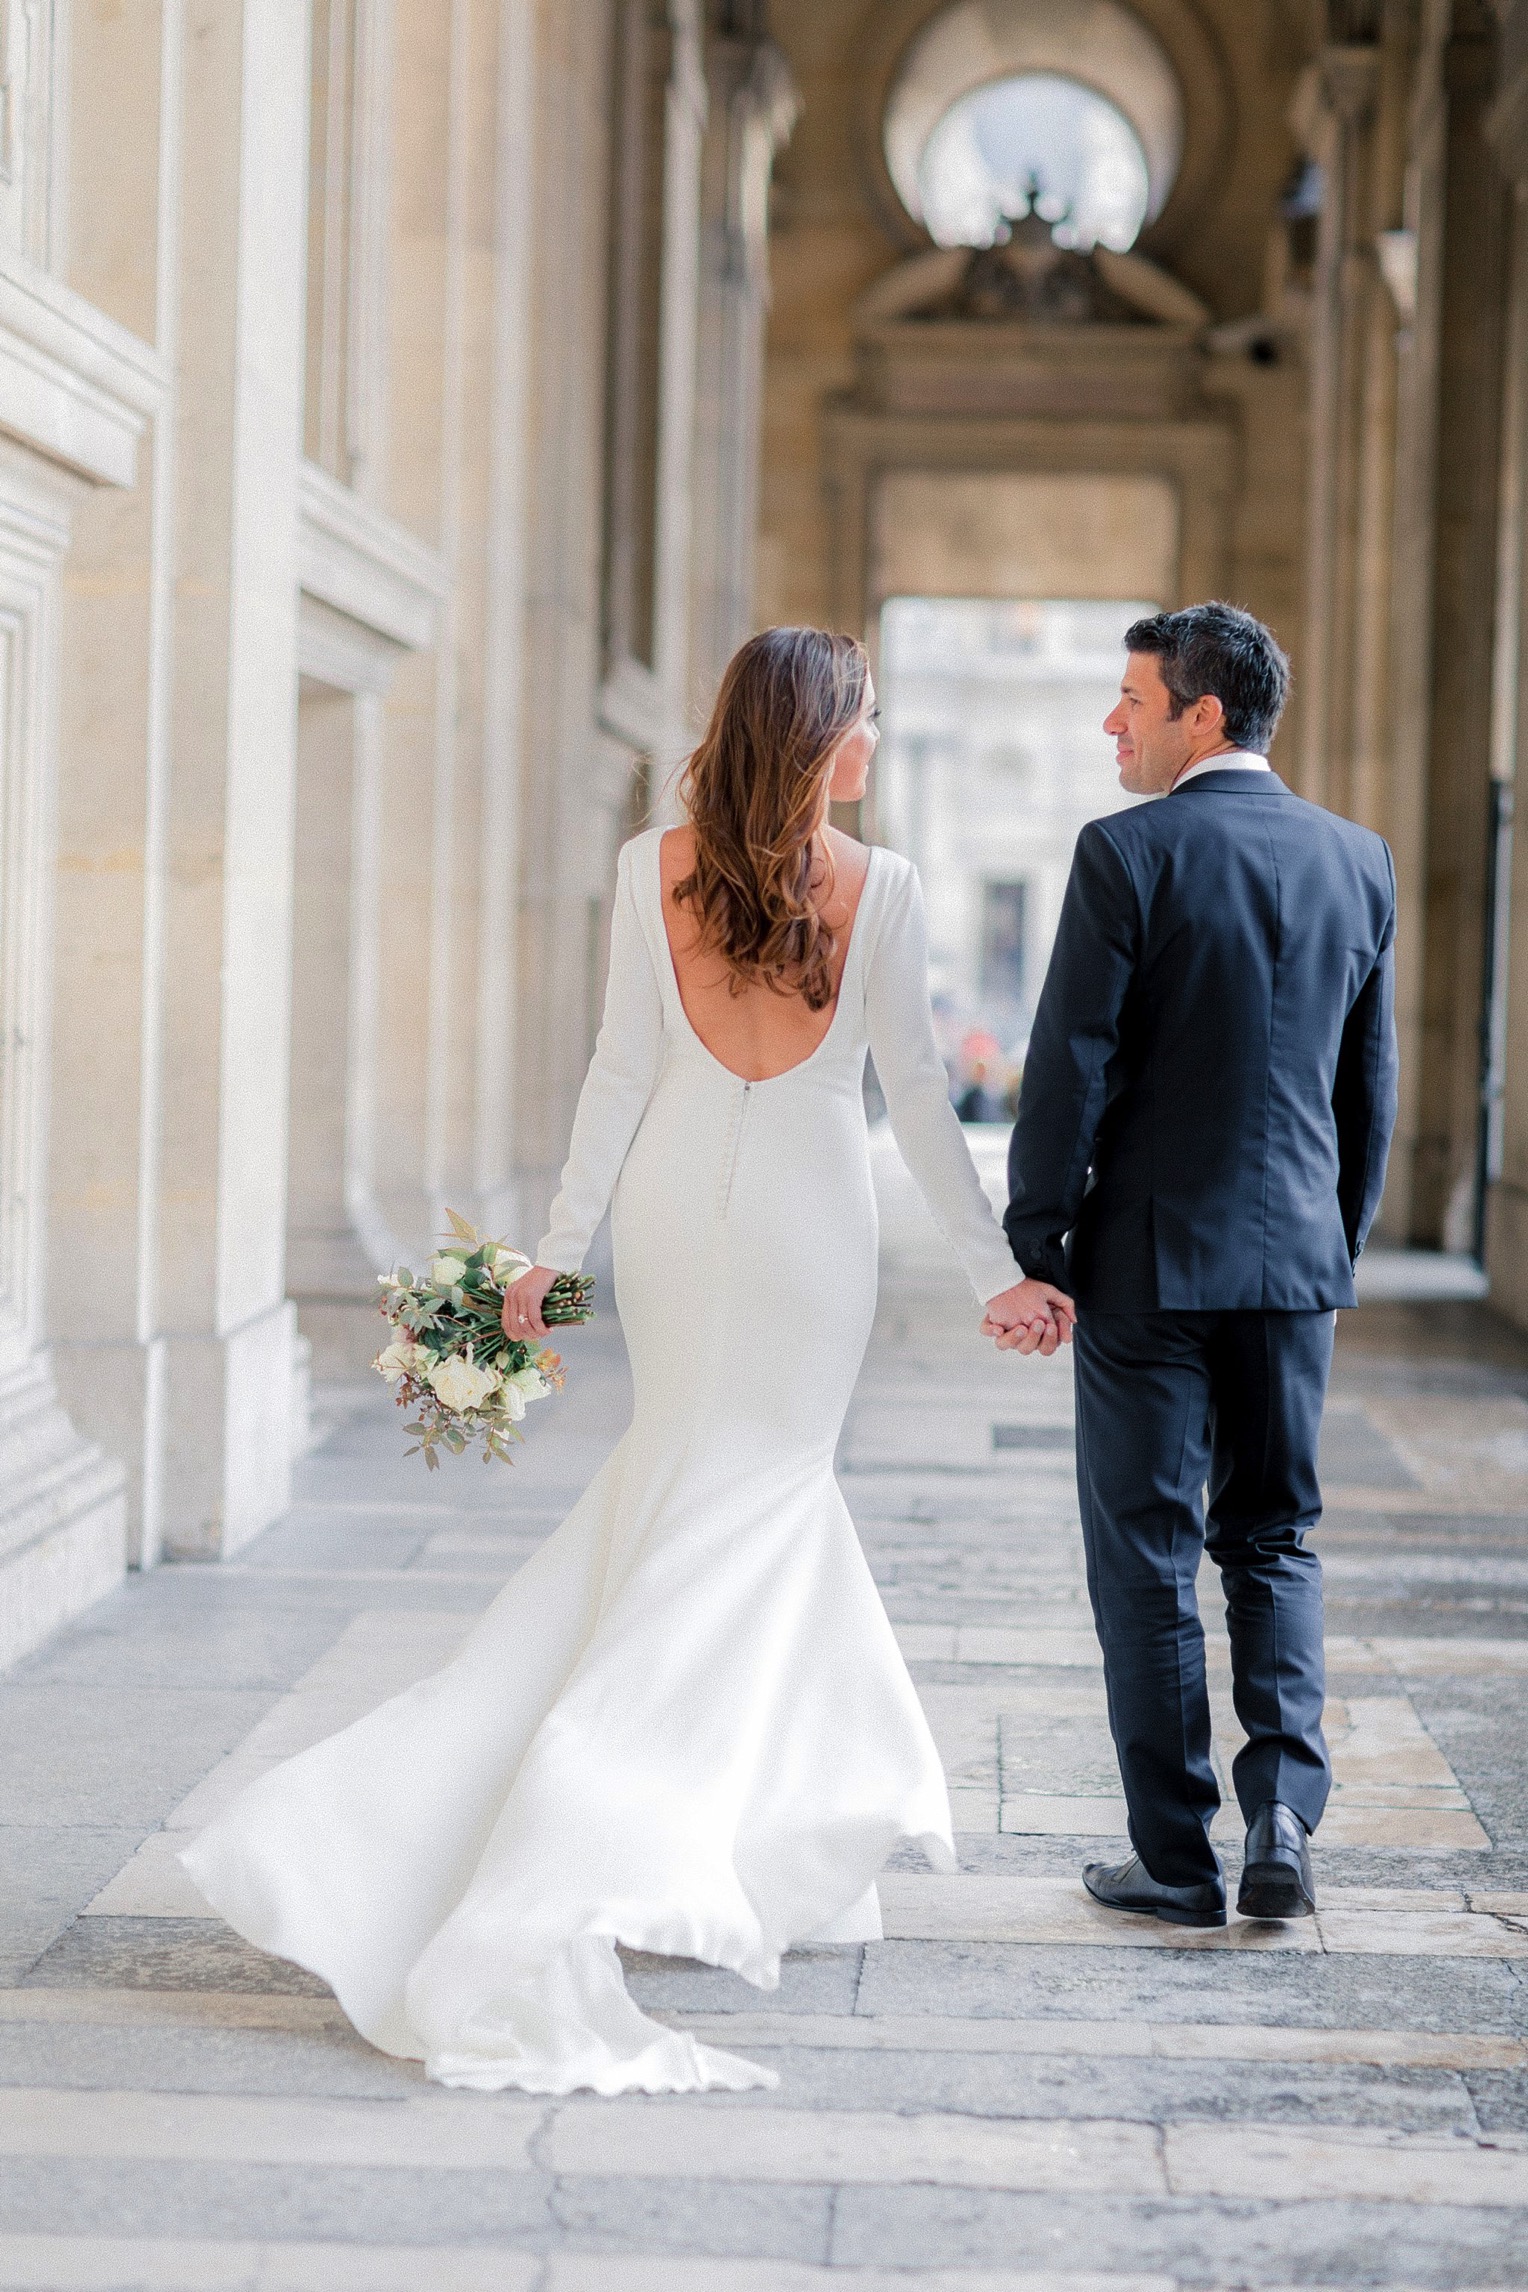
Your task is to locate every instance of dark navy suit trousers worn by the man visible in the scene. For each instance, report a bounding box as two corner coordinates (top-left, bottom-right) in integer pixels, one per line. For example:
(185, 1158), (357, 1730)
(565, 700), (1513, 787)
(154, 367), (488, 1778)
(1074, 1311), (1336, 1886)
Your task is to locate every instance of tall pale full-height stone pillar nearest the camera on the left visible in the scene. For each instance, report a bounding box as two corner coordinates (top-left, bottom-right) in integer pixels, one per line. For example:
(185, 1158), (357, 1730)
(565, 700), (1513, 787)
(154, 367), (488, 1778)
(158, 0), (307, 1559)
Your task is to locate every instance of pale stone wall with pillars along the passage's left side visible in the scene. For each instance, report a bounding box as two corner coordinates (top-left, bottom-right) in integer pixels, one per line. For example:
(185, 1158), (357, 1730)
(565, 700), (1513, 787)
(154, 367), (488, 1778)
(0, 0), (793, 1662)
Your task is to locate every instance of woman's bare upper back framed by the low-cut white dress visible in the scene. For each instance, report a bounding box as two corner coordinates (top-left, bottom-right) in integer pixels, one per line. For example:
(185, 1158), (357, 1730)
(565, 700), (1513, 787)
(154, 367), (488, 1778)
(657, 827), (871, 1082)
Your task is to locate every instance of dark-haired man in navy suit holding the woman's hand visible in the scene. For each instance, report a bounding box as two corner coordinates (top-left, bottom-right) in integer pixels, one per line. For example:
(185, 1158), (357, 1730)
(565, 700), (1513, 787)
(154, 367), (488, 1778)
(983, 605), (1395, 1925)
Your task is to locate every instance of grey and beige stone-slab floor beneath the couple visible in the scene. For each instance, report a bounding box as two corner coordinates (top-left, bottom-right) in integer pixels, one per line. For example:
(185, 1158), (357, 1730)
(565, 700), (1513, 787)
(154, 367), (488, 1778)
(0, 1132), (1528, 2292)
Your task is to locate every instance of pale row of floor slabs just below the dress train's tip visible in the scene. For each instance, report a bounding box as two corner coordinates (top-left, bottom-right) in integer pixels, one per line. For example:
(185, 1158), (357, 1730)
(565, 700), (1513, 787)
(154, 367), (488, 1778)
(0, 2088), (1528, 2212)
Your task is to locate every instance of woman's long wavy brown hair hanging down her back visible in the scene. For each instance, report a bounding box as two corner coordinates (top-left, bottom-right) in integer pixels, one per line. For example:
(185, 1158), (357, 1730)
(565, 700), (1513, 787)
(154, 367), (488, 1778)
(674, 628), (871, 1011)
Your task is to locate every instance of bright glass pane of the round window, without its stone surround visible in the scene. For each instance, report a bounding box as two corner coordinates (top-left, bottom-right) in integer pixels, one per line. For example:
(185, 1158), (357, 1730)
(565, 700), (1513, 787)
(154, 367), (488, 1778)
(919, 71), (1152, 252)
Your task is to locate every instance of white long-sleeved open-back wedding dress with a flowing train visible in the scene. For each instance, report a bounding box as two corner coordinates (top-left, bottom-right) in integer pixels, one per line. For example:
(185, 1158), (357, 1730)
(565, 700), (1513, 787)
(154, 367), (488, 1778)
(183, 832), (1017, 2093)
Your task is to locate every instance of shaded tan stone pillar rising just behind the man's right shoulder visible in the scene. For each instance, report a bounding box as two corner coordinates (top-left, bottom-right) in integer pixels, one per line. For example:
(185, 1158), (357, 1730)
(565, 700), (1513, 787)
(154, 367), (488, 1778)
(1299, 0), (1448, 1240)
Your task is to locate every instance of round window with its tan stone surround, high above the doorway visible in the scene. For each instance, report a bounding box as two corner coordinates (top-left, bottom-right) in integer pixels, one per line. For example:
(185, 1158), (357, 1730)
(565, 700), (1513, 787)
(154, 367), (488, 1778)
(882, 0), (1184, 250)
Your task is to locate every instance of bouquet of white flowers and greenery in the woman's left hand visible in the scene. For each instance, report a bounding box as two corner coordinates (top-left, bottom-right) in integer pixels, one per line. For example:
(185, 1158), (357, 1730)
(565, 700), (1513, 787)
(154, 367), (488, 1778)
(371, 1210), (593, 1471)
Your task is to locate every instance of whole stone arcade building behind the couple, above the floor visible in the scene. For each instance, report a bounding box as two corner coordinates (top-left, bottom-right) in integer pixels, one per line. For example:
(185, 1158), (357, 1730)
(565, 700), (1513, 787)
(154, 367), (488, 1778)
(0, 0), (1528, 1659)
